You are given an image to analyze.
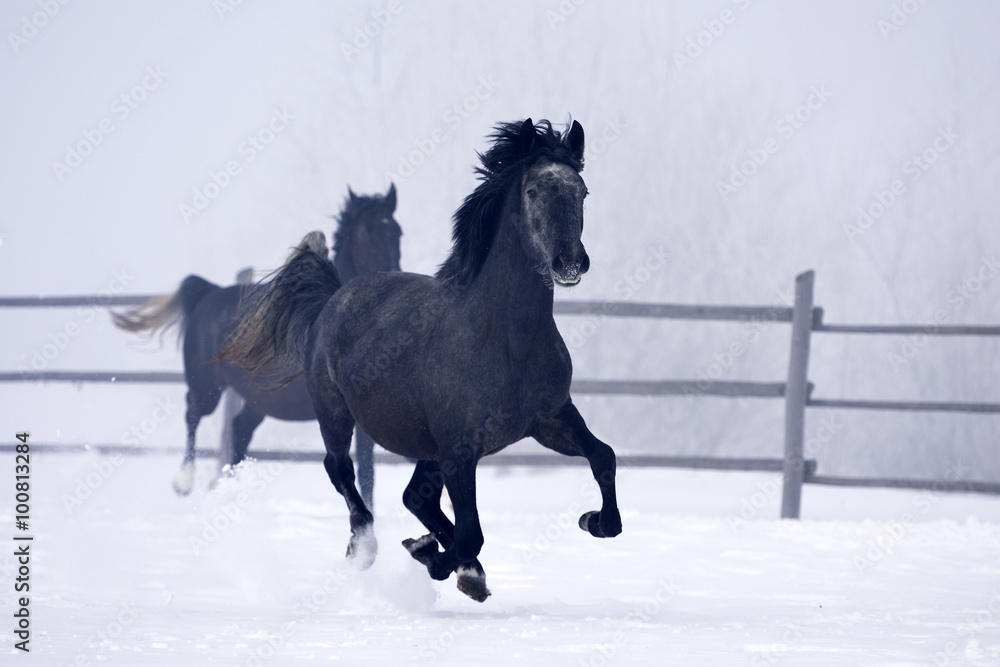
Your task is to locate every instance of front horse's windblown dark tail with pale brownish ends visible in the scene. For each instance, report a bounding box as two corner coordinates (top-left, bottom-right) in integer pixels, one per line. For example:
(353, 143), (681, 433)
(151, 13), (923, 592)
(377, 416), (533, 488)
(216, 232), (341, 380)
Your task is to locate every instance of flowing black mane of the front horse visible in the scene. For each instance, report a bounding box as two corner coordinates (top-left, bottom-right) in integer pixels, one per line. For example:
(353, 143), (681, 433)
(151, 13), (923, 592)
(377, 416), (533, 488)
(437, 120), (583, 285)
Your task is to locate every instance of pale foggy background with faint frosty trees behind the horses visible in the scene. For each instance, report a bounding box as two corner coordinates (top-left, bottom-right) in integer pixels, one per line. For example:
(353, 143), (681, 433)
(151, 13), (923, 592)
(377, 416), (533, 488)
(0, 0), (1000, 480)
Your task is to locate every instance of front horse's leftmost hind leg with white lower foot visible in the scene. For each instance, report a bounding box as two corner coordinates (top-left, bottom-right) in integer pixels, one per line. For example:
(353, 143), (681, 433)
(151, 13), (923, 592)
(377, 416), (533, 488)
(310, 387), (378, 569)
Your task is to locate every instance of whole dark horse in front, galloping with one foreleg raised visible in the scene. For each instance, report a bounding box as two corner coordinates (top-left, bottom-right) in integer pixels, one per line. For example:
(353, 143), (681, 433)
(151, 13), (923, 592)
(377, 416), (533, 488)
(222, 119), (621, 602)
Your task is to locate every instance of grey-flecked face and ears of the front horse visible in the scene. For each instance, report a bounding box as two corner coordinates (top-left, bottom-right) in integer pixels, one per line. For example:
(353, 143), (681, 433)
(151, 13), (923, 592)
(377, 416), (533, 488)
(519, 119), (590, 287)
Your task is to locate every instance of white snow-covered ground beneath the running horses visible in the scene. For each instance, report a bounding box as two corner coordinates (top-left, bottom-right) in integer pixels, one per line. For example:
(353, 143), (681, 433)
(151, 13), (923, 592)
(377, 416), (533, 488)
(0, 454), (1000, 667)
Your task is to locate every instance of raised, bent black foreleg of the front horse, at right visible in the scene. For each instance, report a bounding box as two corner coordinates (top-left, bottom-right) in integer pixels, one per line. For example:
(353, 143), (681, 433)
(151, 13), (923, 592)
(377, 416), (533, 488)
(531, 401), (622, 537)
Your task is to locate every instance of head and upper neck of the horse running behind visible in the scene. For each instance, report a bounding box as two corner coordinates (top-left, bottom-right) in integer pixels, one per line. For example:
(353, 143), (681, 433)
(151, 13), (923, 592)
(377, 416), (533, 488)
(334, 184), (403, 282)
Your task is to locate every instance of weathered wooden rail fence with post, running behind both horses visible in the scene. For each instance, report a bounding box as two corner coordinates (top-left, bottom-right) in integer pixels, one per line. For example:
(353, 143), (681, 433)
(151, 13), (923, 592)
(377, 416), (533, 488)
(0, 271), (1000, 519)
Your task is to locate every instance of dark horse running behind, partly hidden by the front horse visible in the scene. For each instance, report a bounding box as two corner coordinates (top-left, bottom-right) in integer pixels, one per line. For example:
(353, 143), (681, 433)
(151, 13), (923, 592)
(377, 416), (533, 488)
(112, 185), (402, 502)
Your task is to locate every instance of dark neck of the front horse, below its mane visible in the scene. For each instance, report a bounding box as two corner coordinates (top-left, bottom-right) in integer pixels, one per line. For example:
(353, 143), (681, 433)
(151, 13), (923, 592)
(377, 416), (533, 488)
(470, 206), (552, 344)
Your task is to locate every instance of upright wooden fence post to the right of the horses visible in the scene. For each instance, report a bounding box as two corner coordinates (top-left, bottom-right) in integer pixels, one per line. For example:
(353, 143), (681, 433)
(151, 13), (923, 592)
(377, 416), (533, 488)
(781, 271), (816, 519)
